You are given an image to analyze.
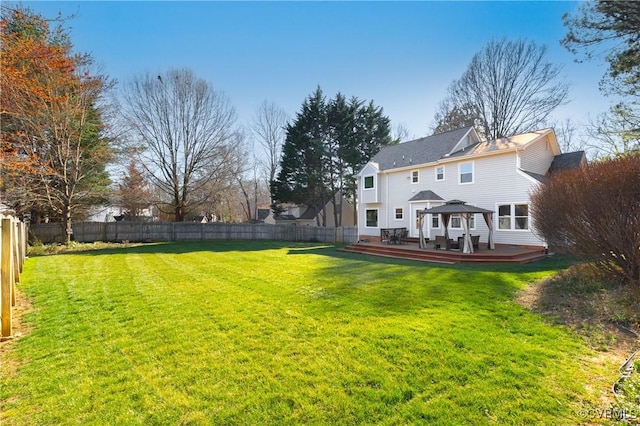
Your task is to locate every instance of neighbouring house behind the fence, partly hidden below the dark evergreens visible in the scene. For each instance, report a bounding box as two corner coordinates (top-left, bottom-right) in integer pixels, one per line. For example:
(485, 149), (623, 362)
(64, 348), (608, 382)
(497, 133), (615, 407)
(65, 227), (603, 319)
(274, 194), (355, 227)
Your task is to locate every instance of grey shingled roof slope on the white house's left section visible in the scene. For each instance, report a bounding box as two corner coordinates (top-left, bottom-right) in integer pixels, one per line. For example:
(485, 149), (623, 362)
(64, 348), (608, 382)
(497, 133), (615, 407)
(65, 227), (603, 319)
(371, 127), (473, 170)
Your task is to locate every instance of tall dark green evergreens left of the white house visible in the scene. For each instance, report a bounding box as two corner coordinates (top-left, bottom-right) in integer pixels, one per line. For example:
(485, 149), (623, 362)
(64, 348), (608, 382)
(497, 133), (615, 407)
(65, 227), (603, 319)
(271, 87), (394, 226)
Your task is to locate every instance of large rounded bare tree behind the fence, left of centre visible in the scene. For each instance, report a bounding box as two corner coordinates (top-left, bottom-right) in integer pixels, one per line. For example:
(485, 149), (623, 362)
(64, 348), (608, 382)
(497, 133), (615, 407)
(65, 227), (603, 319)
(123, 69), (236, 221)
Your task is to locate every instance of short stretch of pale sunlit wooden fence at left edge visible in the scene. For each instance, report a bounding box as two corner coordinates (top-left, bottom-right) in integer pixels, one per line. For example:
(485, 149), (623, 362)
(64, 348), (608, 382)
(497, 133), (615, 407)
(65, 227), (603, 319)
(0, 214), (27, 340)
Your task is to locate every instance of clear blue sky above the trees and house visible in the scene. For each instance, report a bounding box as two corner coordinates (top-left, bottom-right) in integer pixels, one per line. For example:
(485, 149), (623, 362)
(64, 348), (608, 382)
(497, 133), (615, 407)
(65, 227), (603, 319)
(18, 1), (610, 137)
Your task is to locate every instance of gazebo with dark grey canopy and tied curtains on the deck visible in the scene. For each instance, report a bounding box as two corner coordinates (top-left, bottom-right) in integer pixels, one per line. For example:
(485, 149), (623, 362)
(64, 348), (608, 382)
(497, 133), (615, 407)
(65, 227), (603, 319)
(420, 200), (496, 253)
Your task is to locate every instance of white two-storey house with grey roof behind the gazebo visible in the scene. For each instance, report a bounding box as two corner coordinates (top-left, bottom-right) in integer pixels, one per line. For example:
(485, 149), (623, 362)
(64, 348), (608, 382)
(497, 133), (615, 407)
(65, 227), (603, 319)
(358, 127), (586, 246)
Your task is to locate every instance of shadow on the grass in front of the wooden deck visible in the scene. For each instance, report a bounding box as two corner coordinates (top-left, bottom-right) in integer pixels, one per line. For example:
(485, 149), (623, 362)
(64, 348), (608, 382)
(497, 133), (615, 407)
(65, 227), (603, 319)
(288, 246), (573, 316)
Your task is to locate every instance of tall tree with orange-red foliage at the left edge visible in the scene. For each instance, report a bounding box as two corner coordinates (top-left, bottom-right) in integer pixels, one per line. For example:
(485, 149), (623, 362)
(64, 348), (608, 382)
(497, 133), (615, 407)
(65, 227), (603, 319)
(0, 6), (111, 241)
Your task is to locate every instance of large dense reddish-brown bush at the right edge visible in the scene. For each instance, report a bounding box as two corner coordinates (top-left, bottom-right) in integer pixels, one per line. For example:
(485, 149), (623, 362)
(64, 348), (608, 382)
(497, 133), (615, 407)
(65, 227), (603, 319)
(532, 154), (640, 302)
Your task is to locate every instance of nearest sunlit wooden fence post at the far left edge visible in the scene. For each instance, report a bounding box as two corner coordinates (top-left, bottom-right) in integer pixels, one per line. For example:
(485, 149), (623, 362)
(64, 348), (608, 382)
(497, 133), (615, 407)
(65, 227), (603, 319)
(0, 218), (13, 340)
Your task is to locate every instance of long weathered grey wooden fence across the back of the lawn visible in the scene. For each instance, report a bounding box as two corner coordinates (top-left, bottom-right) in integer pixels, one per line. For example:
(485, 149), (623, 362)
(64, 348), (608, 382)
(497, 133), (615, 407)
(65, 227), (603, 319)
(29, 222), (358, 244)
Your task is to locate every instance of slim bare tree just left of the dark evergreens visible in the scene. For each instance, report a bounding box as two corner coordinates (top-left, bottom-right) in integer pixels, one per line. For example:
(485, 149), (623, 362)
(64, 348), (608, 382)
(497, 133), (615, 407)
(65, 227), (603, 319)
(251, 101), (288, 203)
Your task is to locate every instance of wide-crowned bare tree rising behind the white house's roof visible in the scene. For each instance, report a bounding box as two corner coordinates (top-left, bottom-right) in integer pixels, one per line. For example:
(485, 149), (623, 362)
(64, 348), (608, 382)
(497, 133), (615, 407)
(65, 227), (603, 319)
(444, 39), (569, 140)
